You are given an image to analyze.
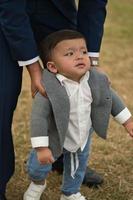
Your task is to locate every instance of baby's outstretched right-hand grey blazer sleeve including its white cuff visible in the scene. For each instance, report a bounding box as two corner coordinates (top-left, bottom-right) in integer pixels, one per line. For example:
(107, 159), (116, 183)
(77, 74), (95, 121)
(111, 89), (131, 124)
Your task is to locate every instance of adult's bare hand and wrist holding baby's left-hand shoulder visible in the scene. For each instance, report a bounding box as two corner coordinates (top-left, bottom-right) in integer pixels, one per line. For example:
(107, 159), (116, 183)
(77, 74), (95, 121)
(27, 61), (47, 98)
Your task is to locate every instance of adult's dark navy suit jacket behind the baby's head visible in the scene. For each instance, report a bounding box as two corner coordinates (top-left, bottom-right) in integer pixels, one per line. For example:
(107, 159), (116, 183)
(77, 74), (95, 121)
(0, 0), (107, 61)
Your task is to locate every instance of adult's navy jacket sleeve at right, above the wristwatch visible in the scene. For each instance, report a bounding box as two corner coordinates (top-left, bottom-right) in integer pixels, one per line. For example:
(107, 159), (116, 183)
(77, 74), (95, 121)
(77, 0), (107, 52)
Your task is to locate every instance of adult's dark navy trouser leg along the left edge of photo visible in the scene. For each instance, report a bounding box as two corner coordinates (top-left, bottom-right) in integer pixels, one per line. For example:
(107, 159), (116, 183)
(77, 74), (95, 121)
(0, 30), (22, 193)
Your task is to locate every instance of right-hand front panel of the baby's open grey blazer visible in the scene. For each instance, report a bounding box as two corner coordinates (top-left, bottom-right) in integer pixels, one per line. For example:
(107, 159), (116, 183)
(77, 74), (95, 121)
(89, 69), (112, 138)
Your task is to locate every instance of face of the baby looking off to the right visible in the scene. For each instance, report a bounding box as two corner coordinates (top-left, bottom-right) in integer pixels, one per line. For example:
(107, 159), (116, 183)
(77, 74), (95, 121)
(52, 39), (90, 81)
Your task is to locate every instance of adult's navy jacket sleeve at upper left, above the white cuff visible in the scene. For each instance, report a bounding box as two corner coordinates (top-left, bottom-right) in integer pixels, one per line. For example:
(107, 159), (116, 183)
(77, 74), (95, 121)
(0, 0), (38, 61)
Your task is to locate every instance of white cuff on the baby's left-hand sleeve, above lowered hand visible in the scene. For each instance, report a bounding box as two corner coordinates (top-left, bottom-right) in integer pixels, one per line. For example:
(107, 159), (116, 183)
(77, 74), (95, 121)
(31, 136), (49, 148)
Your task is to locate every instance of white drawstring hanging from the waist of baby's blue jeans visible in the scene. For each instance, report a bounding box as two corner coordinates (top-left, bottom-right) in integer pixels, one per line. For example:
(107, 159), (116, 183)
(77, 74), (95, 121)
(70, 153), (79, 179)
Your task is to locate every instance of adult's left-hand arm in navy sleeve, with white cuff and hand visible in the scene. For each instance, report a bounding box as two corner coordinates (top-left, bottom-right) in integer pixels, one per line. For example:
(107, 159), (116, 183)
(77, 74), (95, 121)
(0, 0), (44, 95)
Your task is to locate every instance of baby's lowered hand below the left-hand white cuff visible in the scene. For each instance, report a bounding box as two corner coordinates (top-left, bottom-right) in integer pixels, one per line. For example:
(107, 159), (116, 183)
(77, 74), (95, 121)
(36, 147), (54, 164)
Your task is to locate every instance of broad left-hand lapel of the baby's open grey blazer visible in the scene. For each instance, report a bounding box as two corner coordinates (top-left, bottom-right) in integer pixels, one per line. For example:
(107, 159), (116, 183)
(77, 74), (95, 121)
(43, 70), (70, 138)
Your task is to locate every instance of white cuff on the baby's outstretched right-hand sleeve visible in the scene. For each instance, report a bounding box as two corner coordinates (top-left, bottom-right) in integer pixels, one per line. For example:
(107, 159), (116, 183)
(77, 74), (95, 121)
(115, 108), (132, 124)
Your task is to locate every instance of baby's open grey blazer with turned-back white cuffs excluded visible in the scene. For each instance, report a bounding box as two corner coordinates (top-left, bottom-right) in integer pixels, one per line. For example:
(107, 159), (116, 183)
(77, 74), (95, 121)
(31, 69), (125, 157)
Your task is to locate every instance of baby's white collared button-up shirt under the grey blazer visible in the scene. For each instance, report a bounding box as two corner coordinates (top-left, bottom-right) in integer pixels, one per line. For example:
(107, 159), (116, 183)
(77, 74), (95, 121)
(56, 71), (92, 152)
